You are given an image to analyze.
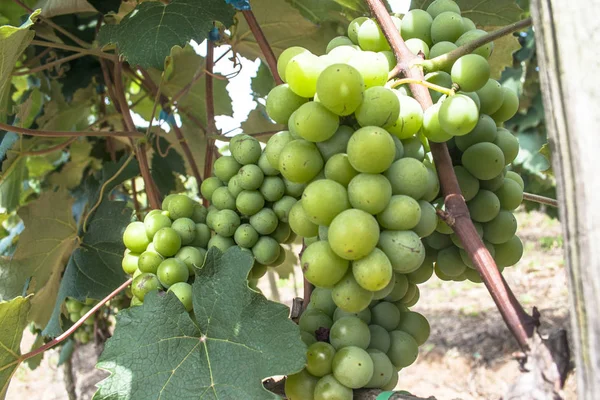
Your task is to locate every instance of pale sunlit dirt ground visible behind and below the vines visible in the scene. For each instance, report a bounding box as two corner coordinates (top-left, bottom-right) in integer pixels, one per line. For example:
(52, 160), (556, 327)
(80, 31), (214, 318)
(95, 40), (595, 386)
(6, 212), (577, 400)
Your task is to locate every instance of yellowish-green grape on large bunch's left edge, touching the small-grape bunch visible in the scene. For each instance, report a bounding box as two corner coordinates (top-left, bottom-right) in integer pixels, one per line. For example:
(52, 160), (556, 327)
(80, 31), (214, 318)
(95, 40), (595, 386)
(279, 140), (323, 183)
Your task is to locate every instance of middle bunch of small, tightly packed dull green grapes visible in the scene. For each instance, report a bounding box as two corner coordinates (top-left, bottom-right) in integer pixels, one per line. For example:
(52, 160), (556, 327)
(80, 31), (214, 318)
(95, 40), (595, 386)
(201, 134), (298, 289)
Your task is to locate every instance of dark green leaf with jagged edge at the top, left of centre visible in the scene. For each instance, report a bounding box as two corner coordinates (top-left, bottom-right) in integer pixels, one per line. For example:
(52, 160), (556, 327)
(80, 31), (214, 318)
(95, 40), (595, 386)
(98, 0), (234, 69)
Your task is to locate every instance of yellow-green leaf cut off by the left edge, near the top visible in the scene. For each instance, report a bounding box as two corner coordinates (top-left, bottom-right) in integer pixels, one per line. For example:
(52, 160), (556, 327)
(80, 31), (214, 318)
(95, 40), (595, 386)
(0, 10), (40, 120)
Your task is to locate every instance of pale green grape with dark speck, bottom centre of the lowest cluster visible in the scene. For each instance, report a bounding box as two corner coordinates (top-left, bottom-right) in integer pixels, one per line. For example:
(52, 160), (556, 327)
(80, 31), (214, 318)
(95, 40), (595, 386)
(333, 346), (373, 389)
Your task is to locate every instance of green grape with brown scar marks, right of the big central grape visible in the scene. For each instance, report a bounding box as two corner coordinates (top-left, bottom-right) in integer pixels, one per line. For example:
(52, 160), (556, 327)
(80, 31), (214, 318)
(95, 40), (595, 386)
(378, 231), (425, 274)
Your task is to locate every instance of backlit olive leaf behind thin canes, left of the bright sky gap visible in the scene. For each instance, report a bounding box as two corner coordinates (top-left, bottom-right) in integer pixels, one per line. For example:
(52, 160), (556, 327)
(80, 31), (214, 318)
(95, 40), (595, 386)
(148, 46), (233, 125)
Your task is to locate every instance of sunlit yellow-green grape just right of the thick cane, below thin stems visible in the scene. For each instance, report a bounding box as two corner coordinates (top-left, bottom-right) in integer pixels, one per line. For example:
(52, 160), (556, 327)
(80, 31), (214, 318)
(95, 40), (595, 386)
(438, 94), (479, 136)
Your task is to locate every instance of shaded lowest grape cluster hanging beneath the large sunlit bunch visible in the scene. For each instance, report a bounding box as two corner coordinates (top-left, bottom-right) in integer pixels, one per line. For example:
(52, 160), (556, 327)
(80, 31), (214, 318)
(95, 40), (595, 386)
(285, 288), (430, 400)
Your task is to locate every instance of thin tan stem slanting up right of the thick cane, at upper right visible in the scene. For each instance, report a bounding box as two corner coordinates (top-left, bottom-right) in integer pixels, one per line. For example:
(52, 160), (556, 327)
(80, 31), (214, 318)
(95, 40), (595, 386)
(418, 18), (532, 76)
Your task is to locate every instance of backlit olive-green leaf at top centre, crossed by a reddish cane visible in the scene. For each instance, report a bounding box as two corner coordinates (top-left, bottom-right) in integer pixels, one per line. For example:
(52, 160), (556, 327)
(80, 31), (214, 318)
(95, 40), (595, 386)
(232, 0), (345, 59)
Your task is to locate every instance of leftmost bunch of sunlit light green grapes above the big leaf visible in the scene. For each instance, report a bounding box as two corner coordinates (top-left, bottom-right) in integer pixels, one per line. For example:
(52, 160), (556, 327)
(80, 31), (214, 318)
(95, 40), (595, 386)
(122, 194), (211, 311)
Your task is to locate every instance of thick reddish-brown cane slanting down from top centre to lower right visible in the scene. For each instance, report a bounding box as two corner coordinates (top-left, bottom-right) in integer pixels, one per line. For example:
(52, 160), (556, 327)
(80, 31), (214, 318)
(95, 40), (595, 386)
(366, 0), (536, 350)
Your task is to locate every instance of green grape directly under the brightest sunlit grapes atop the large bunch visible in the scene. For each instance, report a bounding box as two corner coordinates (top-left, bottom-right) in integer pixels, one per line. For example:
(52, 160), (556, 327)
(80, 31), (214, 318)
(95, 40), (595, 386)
(350, 86), (400, 127)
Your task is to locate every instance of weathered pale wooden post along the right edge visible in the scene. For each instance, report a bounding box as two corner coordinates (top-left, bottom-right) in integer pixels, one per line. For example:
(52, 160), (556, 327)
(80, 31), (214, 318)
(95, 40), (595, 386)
(531, 0), (600, 400)
